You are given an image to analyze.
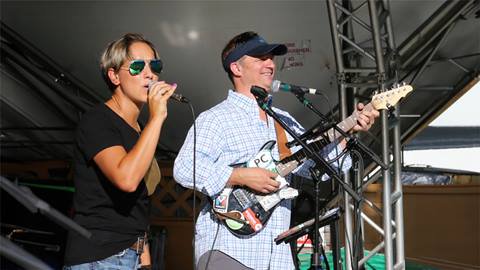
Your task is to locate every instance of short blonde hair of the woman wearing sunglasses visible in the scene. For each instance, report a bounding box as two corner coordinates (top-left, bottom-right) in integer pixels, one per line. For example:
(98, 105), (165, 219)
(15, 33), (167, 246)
(100, 33), (158, 91)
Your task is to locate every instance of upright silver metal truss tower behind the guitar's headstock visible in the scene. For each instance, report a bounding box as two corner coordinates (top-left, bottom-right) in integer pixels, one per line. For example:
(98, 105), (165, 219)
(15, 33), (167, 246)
(327, 0), (405, 269)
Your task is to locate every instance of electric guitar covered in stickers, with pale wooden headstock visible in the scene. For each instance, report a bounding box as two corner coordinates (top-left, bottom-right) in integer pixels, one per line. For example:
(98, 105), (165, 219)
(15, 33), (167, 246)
(212, 85), (413, 236)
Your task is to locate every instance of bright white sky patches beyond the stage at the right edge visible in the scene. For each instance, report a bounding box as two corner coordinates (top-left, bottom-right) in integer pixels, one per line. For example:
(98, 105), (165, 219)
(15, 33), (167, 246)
(404, 82), (480, 172)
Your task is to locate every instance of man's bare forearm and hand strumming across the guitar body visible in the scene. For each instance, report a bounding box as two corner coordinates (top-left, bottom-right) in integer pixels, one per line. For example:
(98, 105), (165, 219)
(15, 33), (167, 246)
(228, 168), (280, 193)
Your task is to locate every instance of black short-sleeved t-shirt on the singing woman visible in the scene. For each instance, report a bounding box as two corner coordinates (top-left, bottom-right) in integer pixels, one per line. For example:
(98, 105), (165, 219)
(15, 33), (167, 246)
(65, 104), (149, 265)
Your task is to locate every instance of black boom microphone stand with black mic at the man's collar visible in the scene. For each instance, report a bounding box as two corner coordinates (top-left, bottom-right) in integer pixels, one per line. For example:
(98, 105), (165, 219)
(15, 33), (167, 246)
(250, 86), (362, 269)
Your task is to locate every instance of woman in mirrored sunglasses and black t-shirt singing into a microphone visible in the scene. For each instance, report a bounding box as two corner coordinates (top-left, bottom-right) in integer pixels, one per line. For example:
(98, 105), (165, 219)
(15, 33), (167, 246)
(65, 34), (177, 270)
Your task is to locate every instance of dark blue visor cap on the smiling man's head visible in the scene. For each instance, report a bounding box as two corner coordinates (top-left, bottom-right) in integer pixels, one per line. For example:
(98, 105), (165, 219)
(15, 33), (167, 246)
(223, 36), (287, 72)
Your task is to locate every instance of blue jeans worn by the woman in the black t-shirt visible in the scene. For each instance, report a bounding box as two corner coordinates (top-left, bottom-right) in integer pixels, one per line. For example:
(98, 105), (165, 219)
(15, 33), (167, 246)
(63, 248), (140, 270)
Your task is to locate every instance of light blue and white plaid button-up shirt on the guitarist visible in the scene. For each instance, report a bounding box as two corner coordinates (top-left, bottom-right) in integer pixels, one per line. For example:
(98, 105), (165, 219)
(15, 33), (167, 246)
(174, 90), (351, 270)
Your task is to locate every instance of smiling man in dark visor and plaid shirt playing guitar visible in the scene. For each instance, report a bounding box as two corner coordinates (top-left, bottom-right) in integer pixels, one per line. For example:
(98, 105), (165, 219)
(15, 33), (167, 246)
(174, 32), (378, 270)
